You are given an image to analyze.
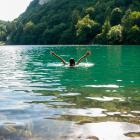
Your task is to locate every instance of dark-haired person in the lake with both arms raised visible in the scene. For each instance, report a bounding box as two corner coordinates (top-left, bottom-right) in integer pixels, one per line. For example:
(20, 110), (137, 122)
(50, 51), (91, 67)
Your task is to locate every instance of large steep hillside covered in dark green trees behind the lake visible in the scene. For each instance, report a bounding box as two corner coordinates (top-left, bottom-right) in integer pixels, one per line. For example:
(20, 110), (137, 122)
(4, 0), (140, 44)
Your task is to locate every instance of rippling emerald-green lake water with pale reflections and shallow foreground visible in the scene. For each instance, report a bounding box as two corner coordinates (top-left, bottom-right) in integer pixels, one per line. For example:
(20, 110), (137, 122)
(0, 45), (140, 140)
